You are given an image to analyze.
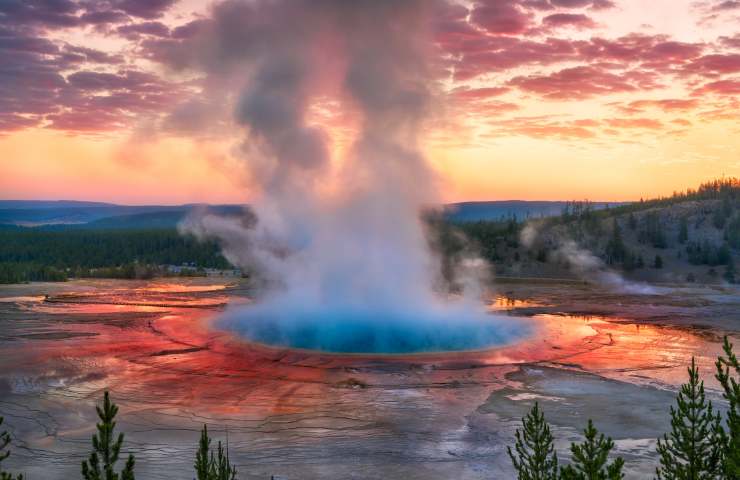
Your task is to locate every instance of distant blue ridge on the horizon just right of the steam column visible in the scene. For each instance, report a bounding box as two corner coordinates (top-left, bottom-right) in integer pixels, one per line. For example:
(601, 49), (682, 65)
(446, 200), (625, 222)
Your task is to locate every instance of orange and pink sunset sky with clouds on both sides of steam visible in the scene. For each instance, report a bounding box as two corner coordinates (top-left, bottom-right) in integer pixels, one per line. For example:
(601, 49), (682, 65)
(0, 0), (740, 204)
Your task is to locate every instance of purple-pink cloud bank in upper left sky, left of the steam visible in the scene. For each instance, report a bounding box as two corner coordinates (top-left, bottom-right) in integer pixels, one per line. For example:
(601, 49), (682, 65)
(0, 0), (187, 133)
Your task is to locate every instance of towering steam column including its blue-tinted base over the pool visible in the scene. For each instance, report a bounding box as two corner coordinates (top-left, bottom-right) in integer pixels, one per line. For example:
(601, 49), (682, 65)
(183, 0), (528, 351)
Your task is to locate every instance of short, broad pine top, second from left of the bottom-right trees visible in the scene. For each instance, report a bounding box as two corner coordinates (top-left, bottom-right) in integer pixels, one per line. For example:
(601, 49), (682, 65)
(560, 419), (624, 480)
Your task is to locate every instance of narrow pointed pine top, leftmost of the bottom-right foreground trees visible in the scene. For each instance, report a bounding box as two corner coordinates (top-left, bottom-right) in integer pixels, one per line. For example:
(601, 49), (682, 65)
(507, 403), (558, 480)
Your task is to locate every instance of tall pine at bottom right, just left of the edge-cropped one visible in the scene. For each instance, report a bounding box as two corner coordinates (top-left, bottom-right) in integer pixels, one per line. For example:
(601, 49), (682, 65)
(656, 358), (726, 480)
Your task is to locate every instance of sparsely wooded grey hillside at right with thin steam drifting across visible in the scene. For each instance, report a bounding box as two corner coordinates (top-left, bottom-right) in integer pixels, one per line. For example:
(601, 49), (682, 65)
(448, 178), (740, 288)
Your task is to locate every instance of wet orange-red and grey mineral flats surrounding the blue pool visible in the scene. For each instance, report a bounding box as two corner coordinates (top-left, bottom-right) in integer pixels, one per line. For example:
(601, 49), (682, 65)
(0, 279), (740, 480)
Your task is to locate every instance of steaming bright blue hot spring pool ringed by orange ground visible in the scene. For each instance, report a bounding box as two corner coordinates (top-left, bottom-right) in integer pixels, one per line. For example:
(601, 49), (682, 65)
(221, 301), (530, 355)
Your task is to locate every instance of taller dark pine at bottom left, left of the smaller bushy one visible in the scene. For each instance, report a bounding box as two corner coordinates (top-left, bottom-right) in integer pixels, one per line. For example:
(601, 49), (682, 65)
(82, 392), (135, 480)
